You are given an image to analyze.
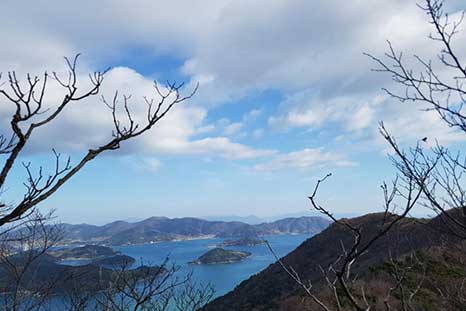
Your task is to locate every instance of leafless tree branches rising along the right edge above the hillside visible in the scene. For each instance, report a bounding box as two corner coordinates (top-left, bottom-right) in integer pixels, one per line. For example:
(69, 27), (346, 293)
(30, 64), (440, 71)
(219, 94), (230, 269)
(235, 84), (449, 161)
(270, 0), (466, 311)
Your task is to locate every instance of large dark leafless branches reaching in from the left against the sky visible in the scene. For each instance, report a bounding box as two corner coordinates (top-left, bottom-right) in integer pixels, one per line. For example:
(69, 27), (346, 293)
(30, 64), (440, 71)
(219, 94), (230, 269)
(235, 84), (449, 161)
(0, 54), (197, 227)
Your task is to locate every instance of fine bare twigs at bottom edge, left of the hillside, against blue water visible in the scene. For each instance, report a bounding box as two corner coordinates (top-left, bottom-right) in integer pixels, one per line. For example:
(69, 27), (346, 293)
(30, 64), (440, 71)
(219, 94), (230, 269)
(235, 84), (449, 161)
(62, 258), (214, 311)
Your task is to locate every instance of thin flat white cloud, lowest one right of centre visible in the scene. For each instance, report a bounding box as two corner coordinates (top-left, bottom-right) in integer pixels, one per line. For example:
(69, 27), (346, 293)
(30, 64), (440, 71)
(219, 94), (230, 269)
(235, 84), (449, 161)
(254, 148), (355, 172)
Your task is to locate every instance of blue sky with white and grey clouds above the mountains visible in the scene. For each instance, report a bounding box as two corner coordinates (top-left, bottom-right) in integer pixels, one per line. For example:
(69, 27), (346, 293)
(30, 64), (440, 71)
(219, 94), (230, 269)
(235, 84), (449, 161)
(0, 0), (466, 224)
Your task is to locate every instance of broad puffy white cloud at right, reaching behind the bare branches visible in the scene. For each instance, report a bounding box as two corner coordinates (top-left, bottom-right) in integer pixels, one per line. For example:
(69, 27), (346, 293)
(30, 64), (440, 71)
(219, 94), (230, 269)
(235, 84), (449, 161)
(268, 86), (466, 149)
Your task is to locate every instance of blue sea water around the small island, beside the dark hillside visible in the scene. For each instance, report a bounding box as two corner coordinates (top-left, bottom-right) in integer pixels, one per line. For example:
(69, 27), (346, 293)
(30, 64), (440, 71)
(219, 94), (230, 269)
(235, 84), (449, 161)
(114, 234), (311, 296)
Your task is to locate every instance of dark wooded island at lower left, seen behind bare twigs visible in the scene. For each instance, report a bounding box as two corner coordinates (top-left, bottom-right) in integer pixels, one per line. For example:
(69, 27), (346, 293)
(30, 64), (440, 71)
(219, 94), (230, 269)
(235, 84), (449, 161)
(0, 245), (157, 295)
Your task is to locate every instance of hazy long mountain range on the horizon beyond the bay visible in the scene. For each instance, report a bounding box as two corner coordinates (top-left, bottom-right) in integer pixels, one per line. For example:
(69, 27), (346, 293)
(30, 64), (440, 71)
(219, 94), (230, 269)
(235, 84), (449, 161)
(59, 217), (329, 245)
